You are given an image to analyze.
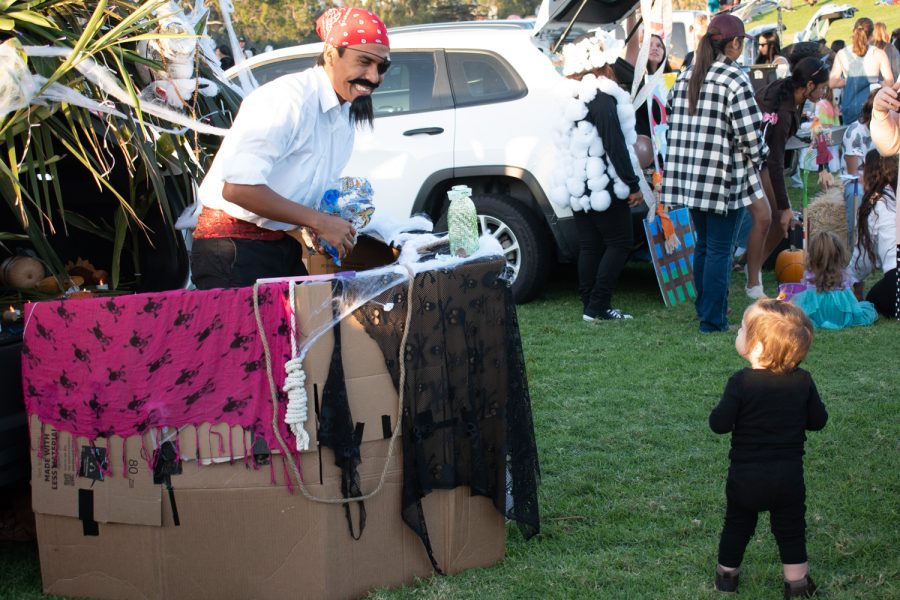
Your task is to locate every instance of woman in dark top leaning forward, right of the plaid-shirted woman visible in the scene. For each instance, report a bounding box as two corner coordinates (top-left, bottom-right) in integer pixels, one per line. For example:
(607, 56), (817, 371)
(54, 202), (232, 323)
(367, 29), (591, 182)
(745, 57), (828, 299)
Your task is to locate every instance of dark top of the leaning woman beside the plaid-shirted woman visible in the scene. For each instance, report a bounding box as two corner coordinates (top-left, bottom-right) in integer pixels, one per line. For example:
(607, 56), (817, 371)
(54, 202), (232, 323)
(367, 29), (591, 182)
(756, 79), (800, 210)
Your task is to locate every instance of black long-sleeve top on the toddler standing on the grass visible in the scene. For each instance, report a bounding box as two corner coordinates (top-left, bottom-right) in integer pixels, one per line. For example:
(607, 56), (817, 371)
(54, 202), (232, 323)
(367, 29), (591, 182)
(709, 368), (828, 462)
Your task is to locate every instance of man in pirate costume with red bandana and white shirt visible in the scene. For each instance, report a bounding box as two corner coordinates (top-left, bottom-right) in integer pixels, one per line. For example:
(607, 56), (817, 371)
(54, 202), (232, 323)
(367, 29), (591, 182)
(191, 8), (390, 289)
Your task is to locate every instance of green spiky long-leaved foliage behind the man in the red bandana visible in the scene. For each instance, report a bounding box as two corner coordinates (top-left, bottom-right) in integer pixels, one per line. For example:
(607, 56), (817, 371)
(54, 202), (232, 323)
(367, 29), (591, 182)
(0, 0), (240, 289)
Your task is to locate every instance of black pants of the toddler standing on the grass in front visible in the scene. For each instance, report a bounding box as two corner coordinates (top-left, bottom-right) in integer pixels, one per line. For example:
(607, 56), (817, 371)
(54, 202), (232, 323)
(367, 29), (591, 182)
(719, 460), (807, 568)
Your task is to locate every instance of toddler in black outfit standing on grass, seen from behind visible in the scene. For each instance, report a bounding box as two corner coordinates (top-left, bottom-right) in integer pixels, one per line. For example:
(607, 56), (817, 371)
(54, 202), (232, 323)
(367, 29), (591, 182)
(709, 298), (828, 598)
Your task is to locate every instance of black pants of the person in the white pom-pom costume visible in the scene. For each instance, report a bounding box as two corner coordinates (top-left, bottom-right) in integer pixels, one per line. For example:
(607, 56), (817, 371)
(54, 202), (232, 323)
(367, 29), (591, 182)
(573, 198), (634, 317)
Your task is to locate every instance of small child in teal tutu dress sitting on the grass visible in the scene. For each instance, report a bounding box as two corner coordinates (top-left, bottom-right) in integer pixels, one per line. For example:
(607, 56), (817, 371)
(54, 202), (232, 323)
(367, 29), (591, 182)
(791, 231), (878, 329)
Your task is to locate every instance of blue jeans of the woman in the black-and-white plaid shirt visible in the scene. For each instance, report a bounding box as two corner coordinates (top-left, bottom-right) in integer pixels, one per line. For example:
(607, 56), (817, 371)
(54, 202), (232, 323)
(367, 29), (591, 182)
(691, 208), (744, 333)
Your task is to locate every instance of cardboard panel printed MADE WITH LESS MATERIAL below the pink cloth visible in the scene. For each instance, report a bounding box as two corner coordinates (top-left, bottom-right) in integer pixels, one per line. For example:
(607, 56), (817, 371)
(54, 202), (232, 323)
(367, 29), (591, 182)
(30, 417), (162, 526)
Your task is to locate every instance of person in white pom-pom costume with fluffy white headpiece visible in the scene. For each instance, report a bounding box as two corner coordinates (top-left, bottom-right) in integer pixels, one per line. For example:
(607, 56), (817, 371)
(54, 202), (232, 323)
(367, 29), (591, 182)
(550, 30), (644, 322)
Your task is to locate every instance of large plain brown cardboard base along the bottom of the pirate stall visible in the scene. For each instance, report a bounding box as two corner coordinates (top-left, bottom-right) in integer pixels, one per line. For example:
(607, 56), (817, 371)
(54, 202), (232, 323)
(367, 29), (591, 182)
(38, 443), (504, 600)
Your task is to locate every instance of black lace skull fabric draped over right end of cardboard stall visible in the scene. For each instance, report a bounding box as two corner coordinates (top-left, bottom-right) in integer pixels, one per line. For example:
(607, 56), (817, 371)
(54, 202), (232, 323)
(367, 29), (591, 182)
(354, 259), (540, 572)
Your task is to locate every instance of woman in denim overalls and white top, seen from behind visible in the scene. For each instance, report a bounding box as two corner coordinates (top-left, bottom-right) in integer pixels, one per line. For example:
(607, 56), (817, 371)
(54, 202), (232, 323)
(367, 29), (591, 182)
(828, 17), (894, 125)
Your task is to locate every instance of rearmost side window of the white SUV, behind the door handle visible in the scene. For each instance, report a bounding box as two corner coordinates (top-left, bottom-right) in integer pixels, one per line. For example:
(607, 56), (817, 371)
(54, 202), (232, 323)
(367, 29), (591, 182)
(447, 51), (528, 106)
